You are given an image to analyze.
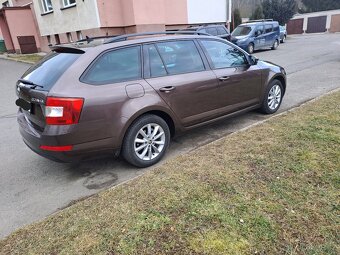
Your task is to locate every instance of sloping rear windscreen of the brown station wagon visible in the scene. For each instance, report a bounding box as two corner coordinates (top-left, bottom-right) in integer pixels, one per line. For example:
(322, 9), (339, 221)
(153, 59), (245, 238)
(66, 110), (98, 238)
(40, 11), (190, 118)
(22, 52), (81, 91)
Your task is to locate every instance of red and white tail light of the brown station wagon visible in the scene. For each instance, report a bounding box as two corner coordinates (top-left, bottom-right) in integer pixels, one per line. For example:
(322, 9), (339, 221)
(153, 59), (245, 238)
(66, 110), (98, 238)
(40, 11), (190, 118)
(45, 97), (84, 125)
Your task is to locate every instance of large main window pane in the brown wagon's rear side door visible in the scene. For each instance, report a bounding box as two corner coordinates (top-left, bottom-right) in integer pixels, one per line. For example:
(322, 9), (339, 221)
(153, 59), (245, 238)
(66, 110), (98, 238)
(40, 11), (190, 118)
(156, 41), (205, 74)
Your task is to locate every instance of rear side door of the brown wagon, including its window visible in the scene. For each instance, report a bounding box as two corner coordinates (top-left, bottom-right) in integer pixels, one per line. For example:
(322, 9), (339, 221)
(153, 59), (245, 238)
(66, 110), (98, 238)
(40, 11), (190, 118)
(144, 40), (218, 126)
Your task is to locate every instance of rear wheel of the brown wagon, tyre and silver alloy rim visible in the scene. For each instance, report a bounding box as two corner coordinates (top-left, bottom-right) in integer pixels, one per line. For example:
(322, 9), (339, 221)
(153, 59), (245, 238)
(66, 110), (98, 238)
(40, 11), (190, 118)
(122, 114), (170, 168)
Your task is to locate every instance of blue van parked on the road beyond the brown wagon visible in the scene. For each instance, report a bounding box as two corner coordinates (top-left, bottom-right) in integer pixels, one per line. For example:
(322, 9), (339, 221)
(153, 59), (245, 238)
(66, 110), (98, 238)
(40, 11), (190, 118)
(231, 20), (280, 54)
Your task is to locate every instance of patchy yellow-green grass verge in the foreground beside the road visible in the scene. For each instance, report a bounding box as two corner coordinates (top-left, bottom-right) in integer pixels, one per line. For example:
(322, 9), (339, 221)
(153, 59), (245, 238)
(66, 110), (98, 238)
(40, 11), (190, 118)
(0, 92), (340, 255)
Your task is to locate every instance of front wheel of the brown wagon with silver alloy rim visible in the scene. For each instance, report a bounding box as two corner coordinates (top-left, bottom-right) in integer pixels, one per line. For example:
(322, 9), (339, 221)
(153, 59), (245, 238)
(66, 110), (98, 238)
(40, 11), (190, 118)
(260, 80), (283, 114)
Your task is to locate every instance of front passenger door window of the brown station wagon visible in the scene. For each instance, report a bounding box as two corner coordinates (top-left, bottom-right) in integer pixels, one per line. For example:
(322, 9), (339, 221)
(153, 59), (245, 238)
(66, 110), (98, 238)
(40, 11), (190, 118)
(201, 40), (248, 69)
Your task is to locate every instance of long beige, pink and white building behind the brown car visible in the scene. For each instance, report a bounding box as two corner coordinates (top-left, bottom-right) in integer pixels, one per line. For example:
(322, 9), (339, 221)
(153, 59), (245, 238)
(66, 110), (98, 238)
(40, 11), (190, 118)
(0, 0), (232, 52)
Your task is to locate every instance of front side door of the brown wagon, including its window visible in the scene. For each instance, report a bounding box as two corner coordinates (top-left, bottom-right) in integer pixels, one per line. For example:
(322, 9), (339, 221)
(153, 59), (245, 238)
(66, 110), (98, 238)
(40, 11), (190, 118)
(200, 39), (262, 113)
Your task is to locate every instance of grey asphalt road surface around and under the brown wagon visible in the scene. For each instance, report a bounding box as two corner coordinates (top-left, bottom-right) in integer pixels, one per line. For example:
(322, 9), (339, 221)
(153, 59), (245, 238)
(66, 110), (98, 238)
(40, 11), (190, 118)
(0, 34), (340, 238)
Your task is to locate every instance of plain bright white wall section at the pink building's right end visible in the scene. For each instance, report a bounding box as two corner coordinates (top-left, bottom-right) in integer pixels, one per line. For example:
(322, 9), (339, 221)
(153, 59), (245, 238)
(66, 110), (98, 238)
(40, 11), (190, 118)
(188, 0), (229, 24)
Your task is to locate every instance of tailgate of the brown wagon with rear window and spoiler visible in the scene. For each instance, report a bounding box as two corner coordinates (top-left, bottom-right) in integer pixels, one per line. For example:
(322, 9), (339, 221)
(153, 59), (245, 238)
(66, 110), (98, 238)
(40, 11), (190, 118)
(16, 47), (84, 132)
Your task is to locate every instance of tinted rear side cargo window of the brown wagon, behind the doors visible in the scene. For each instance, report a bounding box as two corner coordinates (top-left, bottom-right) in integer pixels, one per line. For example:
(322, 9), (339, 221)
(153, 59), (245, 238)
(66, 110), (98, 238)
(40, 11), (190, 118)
(82, 46), (142, 85)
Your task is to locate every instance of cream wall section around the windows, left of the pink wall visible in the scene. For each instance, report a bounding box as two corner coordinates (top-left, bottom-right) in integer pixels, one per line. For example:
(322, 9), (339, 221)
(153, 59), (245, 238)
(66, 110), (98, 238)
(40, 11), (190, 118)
(33, 0), (100, 36)
